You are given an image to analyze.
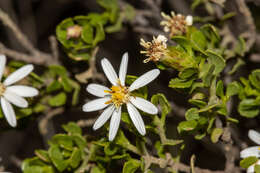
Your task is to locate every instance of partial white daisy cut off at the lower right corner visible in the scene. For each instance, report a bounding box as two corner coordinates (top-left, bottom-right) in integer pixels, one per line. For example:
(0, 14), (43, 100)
(240, 130), (260, 173)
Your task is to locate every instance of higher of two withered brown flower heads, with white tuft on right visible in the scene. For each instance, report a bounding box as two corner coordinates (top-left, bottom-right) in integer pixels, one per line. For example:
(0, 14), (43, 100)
(160, 11), (193, 37)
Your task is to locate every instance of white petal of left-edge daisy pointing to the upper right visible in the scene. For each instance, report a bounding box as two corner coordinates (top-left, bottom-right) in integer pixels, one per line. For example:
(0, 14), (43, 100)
(4, 64), (33, 86)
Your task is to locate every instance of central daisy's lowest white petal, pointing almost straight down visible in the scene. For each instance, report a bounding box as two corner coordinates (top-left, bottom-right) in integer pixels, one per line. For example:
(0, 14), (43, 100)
(108, 106), (121, 141)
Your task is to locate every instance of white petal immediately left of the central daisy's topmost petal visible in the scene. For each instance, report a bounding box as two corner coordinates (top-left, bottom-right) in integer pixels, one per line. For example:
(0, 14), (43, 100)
(101, 58), (118, 85)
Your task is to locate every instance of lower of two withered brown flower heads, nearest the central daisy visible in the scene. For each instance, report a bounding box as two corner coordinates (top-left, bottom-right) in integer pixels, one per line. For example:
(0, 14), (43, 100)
(140, 35), (168, 63)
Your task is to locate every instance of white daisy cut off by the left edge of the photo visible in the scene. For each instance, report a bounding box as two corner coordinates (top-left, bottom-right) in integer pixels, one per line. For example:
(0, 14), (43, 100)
(0, 55), (39, 127)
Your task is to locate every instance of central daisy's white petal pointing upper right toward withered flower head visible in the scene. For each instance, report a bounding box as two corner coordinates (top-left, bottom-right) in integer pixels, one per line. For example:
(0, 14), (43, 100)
(129, 69), (160, 91)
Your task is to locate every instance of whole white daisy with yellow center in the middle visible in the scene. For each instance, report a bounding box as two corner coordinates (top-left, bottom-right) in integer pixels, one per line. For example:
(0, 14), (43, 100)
(83, 53), (160, 141)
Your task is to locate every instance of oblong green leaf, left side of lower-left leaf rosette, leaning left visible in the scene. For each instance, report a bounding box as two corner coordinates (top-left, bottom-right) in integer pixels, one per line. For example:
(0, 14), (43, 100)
(48, 145), (68, 172)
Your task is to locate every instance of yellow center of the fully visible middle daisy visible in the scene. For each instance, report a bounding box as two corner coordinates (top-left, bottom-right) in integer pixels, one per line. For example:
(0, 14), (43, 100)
(105, 85), (130, 108)
